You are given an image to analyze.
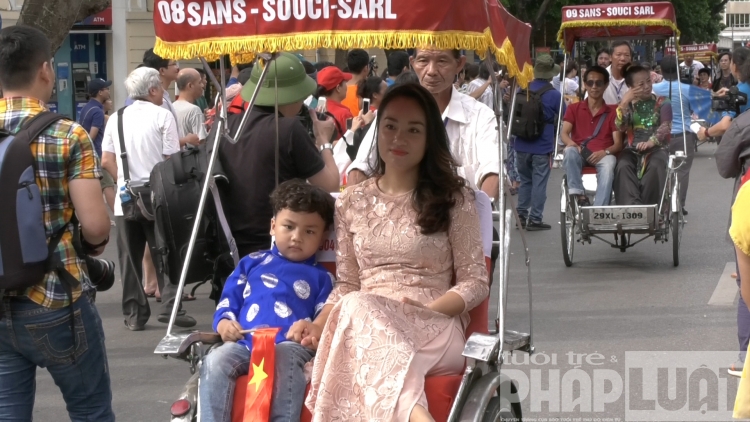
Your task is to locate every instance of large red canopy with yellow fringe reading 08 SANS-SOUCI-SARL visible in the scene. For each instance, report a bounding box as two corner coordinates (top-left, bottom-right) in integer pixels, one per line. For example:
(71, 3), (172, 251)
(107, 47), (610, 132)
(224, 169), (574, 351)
(154, 0), (530, 86)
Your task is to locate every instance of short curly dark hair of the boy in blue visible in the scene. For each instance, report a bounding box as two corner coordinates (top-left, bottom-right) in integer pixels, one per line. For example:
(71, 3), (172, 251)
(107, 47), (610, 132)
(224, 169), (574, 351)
(271, 179), (336, 230)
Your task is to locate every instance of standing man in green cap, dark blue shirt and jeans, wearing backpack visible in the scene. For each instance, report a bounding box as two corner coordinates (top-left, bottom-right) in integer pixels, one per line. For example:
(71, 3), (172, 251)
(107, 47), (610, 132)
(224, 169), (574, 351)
(514, 55), (562, 231)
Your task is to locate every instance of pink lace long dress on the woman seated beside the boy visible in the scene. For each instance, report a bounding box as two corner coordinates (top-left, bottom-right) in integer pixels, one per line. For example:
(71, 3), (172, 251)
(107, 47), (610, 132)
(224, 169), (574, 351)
(306, 179), (489, 422)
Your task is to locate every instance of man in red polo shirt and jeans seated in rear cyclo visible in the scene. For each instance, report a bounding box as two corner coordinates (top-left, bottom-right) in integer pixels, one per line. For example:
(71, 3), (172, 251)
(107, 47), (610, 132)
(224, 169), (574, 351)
(561, 66), (622, 206)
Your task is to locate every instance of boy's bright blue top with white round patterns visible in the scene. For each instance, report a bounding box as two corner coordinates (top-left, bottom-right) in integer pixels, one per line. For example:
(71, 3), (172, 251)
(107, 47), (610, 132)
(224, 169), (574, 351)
(213, 245), (333, 350)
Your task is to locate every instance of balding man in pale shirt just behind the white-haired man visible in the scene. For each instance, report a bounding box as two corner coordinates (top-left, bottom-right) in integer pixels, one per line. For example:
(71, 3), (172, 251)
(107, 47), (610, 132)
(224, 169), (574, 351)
(172, 68), (208, 141)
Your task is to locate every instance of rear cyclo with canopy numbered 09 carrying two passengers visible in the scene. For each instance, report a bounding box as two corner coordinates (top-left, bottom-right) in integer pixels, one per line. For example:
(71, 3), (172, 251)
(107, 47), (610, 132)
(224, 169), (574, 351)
(558, 2), (687, 267)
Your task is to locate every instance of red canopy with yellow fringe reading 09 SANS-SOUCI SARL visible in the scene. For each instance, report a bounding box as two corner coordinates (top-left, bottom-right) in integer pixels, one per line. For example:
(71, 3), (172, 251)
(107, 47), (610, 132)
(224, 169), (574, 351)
(557, 2), (679, 52)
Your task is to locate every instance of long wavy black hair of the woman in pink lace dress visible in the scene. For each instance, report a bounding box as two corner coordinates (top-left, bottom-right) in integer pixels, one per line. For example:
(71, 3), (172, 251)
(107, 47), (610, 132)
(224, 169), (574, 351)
(372, 83), (466, 235)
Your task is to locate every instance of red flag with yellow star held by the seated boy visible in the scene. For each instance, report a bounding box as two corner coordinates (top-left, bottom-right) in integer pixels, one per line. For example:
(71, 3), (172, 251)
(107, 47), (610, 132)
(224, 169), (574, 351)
(243, 328), (279, 422)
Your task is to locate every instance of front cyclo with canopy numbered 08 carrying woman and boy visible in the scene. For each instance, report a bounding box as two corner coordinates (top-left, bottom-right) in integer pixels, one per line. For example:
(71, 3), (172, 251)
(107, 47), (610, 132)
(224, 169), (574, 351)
(148, 0), (534, 421)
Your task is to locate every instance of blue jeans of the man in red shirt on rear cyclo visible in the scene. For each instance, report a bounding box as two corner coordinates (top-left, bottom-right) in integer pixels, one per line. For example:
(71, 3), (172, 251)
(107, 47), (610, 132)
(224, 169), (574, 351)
(563, 147), (617, 207)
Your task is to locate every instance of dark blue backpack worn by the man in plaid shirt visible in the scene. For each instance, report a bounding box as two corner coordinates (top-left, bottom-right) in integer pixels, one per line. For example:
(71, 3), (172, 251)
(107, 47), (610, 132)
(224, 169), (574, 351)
(0, 112), (78, 292)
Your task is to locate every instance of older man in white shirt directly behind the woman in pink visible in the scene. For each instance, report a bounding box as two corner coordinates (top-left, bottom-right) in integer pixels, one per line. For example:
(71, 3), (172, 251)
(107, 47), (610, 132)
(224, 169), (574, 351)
(347, 48), (500, 198)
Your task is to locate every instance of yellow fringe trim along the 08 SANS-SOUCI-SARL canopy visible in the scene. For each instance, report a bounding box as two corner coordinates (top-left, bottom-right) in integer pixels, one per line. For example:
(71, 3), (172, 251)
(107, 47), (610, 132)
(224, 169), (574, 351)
(154, 28), (534, 87)
